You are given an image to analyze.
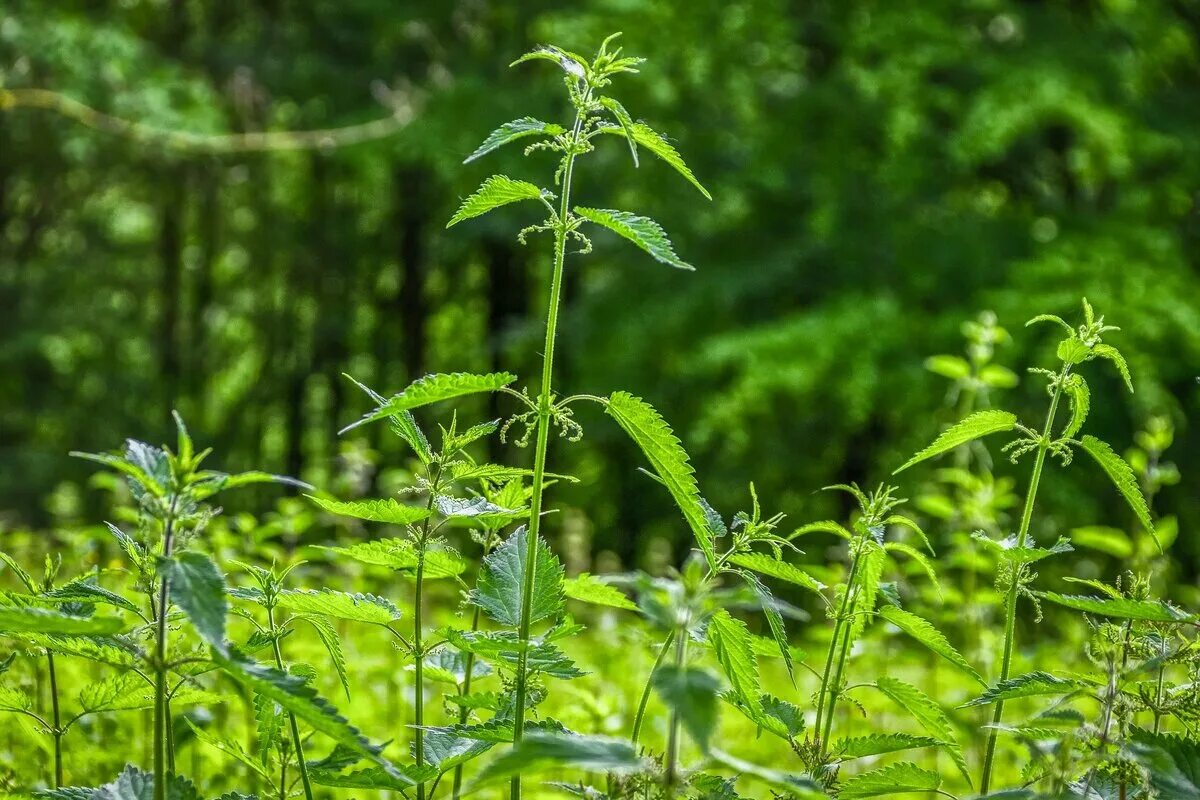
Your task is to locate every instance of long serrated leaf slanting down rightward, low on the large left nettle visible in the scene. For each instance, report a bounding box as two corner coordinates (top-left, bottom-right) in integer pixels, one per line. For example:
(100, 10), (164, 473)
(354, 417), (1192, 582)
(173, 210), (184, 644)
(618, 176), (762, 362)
(212, 648), (400, 776)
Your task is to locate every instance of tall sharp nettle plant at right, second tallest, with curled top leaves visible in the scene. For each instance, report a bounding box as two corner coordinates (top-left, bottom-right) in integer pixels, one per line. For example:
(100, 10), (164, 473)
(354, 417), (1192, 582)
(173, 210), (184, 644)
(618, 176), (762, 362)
(896, 300), (1154, 793)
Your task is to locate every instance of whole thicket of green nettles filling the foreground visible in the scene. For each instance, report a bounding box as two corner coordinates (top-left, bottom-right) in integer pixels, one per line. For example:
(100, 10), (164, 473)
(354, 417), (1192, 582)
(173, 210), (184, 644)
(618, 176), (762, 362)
(0, 37), (1200, 800)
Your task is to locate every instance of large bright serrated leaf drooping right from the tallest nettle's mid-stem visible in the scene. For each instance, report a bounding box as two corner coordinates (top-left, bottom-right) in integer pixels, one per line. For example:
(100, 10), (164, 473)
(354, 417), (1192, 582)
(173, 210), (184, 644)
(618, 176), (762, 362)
(605, 392), (716, 566)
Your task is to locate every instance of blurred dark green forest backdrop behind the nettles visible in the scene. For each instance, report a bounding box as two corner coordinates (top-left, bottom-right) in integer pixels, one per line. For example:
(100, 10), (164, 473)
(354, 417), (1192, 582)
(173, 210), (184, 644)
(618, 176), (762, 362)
(0, 0), (1200, 575)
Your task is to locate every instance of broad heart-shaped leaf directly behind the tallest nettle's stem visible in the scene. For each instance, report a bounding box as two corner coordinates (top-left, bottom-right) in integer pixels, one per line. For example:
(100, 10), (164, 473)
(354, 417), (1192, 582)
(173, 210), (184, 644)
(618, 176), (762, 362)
(467, 527), (563, 627)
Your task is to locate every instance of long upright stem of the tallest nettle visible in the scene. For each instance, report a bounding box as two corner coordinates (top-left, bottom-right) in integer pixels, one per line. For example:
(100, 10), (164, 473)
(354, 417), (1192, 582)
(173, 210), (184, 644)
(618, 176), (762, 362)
(509, 89), (592, 800)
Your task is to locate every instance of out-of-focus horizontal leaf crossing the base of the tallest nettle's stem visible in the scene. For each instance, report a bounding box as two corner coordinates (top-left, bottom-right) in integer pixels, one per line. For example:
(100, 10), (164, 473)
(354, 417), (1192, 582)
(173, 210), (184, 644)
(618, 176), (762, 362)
(467, 732), (642, 792)
